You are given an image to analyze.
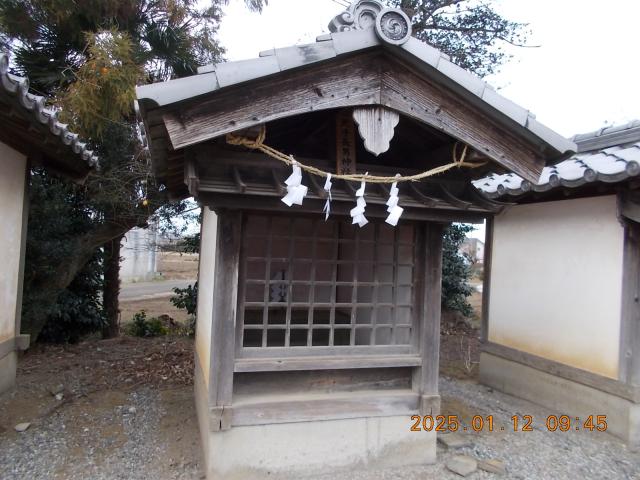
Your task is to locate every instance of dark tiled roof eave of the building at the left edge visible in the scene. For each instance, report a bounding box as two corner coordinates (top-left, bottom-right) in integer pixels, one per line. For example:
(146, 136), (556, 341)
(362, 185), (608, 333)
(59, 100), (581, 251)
(0, 52), (98, 180)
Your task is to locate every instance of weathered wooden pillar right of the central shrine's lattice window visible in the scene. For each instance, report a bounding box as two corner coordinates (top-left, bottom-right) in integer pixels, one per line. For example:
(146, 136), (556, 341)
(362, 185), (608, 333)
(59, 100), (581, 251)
(412, 223), (444, 415)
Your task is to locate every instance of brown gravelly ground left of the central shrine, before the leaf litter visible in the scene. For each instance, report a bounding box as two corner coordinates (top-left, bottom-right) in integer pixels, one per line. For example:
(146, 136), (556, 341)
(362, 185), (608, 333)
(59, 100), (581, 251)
(0, 387), (203, 480)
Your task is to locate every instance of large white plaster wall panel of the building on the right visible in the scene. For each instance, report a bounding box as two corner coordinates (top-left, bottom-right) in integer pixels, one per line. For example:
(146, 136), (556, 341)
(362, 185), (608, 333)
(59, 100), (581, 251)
(488, 196), (623, 378)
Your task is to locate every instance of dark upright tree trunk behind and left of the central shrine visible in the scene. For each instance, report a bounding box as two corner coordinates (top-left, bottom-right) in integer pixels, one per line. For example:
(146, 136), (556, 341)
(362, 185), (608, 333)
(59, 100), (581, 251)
(102, 235), (123, 338)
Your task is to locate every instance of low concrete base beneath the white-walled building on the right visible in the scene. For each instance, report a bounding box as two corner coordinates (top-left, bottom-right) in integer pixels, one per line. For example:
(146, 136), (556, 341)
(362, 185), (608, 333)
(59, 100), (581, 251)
(480, 352), (640, 449)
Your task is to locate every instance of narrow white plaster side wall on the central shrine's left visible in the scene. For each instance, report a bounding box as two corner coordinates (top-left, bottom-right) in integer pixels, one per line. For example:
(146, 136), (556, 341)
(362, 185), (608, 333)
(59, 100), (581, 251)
(196, 207), (218, 386)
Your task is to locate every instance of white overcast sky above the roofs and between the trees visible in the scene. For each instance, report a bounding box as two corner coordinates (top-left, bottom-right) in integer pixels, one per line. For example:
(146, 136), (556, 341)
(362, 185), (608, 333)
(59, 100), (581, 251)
(212, 0), (640, 238)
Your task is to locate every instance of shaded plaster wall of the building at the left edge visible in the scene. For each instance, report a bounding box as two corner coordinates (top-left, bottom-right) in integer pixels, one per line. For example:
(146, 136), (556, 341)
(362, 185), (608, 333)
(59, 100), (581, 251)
(0, 142), (27, 341)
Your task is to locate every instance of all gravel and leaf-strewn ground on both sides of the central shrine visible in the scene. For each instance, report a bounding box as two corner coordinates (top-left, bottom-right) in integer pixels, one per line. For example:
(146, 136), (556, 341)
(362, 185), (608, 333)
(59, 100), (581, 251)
(0, 337), (640, 480)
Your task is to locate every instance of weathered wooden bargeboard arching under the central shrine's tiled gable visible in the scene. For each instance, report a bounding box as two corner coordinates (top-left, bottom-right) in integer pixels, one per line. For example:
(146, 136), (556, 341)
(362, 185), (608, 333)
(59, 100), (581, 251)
(162, 53), (544, 181)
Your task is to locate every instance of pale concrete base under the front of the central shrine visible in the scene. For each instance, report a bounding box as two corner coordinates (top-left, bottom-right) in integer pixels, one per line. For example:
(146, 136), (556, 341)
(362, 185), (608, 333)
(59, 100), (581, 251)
(205, 415), (436, 480)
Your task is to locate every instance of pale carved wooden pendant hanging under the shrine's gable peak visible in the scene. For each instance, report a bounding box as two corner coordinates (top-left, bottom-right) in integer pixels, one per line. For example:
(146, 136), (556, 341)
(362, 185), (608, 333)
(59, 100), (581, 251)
(353, 107), (400, 157)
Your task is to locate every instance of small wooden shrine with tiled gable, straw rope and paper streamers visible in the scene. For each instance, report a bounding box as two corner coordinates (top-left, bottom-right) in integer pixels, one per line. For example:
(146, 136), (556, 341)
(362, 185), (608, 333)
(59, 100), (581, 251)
(137, 0), (574, 479)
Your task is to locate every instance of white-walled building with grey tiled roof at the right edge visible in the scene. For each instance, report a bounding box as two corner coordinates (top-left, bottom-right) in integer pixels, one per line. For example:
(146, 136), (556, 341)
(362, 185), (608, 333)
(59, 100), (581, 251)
(475, 121), (640, 447)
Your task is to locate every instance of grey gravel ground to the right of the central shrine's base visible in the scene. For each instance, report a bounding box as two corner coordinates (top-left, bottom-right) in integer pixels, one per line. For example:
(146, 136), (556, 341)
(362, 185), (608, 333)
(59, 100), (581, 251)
(313, 378), (640, 480)
